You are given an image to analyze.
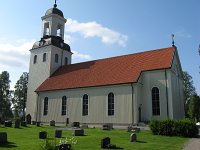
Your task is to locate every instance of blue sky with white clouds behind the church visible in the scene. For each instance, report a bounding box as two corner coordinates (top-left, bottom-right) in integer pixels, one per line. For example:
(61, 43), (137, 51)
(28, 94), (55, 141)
(0, 0), (200, 94)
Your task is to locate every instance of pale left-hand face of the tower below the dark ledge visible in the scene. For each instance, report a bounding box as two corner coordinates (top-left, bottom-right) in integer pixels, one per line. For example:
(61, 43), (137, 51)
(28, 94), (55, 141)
(26, 46), (51, 120)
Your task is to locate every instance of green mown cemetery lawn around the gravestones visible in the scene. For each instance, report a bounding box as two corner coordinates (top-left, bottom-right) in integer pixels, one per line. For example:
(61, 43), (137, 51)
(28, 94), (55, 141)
(0, 125), (189, 150)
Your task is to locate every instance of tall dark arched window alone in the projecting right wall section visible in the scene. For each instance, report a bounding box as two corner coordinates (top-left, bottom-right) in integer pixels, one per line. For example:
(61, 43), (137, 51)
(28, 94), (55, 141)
(151, 87), (160, 116)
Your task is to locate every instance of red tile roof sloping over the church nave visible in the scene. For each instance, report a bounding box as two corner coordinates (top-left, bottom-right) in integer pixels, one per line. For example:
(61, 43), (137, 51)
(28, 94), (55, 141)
(36, 47), (175, 92)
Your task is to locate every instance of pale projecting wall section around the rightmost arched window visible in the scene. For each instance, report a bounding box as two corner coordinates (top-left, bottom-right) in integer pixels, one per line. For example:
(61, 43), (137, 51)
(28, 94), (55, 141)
(138, 70), (168, 121)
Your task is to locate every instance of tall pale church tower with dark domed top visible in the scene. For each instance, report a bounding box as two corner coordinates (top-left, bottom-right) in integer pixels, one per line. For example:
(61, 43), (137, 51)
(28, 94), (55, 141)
(26, 1), (72, 121)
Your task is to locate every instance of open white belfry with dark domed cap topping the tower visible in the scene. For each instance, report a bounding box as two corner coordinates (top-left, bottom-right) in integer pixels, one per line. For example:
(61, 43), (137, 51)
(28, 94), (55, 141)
(42, 0), (66, 40)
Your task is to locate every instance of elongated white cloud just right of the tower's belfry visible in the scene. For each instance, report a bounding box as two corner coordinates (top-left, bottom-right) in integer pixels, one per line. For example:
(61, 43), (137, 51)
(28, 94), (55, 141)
(66, 19), (128, 47)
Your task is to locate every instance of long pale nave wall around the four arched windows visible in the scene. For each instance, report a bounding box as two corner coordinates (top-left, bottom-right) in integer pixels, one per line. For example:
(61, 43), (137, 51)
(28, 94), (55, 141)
(39, 84), (132, 124)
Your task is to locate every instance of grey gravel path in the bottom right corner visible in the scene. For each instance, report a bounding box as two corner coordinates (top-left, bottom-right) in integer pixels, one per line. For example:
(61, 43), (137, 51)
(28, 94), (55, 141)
(183, 138), (200, 150)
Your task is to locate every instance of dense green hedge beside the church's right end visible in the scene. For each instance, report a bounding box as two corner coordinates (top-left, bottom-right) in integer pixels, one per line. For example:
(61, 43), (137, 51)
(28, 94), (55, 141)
(149, 119), (198, 137)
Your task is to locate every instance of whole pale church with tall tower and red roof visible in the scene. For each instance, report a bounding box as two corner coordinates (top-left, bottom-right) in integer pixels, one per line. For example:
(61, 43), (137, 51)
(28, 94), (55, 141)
(26, 4), (184, 125)
